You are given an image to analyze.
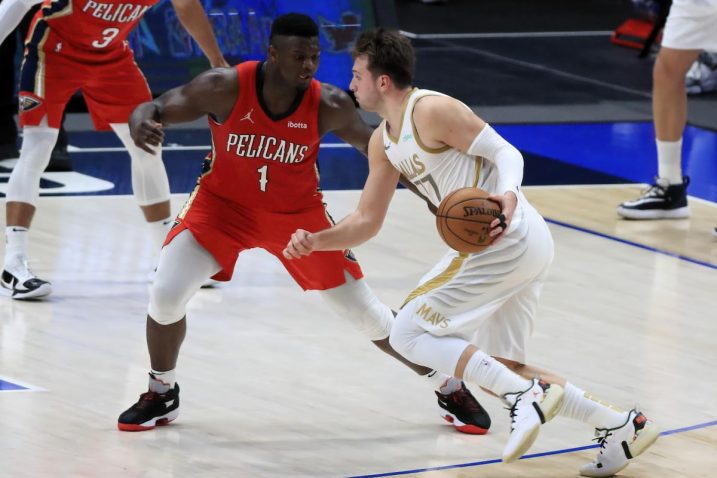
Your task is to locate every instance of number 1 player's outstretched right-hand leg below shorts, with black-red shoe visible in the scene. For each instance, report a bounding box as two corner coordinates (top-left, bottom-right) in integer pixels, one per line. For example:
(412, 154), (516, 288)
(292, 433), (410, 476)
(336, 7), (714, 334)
(319, 273), (491, 435)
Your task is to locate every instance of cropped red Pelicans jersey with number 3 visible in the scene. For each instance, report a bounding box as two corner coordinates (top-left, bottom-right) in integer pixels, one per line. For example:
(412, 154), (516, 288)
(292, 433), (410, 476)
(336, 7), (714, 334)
(27, 0), (159, 54)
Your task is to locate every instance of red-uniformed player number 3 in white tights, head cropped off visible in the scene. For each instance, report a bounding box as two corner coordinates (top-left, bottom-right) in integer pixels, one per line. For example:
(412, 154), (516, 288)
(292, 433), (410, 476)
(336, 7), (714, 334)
(0, 0), (228, 299)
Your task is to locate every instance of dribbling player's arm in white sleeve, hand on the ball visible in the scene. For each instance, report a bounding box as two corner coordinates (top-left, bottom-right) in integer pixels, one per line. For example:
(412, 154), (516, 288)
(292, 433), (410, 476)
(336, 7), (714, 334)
(413, 96), (523, 240)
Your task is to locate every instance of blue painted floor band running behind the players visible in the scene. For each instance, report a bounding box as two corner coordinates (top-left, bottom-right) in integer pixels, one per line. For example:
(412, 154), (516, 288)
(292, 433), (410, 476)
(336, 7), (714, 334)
(0, 122), (717, 202)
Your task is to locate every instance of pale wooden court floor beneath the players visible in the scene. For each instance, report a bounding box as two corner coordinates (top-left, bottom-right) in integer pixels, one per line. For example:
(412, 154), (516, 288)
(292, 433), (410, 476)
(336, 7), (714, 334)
(0, 187), (717, 478)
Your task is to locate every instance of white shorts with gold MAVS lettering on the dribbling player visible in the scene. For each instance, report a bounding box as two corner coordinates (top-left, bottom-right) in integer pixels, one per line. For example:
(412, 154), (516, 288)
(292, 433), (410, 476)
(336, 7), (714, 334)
(406, 195), (554, 363)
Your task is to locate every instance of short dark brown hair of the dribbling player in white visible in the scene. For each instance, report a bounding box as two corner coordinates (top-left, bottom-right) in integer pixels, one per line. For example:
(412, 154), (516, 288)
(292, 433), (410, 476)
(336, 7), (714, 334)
(352, 28), (416, 88)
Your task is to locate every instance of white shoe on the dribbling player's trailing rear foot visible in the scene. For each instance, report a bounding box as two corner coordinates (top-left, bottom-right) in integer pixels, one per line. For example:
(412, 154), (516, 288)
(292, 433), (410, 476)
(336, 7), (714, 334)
(580, 408), (660, 477)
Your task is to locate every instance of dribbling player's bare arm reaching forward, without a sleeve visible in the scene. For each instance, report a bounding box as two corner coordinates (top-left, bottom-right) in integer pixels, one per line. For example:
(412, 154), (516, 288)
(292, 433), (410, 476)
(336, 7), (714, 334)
(284, 130), (399, 259)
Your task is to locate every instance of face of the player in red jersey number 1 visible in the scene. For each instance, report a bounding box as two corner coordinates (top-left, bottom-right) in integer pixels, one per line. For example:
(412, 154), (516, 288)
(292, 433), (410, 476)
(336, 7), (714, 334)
(269, 37), (321, 90)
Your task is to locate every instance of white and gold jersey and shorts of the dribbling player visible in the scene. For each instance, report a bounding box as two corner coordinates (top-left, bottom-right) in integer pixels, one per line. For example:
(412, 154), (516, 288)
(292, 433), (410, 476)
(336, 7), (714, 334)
(383, 89), (553, 362)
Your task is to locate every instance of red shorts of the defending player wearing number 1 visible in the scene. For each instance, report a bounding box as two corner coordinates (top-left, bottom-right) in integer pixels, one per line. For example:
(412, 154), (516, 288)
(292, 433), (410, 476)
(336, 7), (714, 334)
(164, 187), (363, 290)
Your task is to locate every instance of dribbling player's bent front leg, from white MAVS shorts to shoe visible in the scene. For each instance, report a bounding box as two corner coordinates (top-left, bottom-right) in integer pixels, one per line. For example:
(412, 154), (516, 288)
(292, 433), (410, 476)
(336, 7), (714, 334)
(390, 213), (563, 462)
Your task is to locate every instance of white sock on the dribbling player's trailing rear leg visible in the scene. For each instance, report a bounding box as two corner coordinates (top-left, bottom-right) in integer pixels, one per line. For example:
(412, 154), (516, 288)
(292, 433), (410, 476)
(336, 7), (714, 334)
(558, 383), (626, 428)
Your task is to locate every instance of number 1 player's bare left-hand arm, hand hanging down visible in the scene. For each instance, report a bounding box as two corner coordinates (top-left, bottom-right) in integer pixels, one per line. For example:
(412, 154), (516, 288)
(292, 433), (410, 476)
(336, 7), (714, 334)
(129, 68), (239, 154)
